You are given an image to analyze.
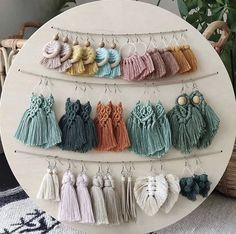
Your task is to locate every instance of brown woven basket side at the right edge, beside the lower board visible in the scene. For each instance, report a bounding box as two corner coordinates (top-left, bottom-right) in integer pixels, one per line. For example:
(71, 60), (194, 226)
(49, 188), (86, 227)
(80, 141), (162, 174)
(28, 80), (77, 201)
(216, 142), (236, 198)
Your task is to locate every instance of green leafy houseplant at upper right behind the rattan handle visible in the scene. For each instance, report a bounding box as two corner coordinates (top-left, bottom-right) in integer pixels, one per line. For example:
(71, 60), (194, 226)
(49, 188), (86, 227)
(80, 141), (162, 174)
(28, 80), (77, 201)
(177, 0), (236, 91)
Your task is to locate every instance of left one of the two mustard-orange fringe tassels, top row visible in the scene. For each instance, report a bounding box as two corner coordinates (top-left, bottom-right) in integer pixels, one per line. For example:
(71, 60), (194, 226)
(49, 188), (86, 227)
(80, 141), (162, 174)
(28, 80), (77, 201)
(170, 47), (191, 74)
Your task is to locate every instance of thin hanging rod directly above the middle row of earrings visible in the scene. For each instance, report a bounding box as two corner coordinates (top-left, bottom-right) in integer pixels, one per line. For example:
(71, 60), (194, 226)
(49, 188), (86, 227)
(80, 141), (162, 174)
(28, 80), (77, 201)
(18, 69), (219, 87)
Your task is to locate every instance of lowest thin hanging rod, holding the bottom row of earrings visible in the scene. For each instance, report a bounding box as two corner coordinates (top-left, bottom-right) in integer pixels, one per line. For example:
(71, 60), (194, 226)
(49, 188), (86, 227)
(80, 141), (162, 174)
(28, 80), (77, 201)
(14, 150), (223, 164)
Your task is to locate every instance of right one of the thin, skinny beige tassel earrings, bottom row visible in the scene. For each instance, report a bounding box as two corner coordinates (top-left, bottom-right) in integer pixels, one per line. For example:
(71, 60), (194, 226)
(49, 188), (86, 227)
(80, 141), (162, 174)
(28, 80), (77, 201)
(126, 163), (137, 221)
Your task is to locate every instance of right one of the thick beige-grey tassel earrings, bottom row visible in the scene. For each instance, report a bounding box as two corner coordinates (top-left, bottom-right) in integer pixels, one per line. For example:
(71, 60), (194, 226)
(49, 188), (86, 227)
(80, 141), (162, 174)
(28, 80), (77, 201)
(103, 166), (123, 224)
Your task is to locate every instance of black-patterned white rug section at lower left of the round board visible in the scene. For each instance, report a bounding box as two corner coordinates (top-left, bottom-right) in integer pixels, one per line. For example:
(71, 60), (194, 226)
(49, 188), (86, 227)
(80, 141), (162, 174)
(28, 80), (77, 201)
(0, 187), (82, 234)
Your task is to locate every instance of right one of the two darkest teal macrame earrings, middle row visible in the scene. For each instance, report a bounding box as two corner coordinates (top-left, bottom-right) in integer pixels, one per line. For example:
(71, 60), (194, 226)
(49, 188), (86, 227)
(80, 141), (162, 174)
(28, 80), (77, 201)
(79, 102), (97, 153)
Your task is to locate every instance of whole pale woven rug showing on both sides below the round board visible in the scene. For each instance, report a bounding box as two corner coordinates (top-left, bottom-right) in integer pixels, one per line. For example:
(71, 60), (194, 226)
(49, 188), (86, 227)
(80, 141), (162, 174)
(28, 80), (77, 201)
(0, 187), (236, 234)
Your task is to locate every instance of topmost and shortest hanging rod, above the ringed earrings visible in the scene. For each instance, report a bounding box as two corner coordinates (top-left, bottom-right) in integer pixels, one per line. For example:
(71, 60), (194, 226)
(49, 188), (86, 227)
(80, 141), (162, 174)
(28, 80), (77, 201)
(51, 26), (188, 37)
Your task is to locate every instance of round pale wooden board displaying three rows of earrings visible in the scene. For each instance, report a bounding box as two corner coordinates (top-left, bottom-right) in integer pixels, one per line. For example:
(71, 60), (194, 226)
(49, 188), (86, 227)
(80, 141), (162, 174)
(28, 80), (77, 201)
(0, 1), (236, 234)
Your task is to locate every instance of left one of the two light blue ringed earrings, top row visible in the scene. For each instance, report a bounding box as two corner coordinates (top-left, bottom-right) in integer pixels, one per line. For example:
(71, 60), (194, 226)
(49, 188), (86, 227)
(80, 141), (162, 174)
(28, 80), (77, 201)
(96, 39), (111, 77)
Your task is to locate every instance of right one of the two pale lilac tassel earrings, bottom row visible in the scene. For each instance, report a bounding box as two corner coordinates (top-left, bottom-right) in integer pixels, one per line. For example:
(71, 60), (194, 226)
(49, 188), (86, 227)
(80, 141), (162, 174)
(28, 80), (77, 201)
(76, 163), (95, 224)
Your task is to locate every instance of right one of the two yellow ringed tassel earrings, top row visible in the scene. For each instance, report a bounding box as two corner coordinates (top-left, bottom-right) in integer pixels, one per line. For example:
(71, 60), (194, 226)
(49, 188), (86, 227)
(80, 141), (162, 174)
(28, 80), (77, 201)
(82, 38), (98, 76)
